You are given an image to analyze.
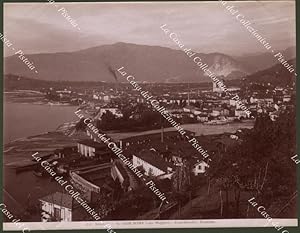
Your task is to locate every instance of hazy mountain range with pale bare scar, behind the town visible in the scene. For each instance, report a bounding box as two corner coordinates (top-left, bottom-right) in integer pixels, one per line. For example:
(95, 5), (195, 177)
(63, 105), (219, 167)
(4, 43), (295, 83)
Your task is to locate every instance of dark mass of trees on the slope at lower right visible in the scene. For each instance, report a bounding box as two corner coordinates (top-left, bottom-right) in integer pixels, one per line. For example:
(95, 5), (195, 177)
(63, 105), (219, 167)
(215, 107), (296, 217)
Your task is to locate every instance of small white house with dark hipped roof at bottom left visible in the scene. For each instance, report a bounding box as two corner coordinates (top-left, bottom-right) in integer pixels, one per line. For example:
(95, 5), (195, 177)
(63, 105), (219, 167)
(39, 192), (73, 222)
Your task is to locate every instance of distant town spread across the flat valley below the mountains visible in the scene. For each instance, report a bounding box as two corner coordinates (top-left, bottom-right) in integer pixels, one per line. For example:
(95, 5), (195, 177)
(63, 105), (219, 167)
(46, 81), (295, 124)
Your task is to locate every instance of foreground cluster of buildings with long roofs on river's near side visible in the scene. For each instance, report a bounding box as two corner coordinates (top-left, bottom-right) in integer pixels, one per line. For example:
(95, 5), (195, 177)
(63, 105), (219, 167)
(39, 126), (227, 221)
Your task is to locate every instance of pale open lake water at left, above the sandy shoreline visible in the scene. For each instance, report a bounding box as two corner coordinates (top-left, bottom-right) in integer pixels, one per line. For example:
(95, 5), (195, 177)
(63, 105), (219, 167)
(3, 102), (78, 144)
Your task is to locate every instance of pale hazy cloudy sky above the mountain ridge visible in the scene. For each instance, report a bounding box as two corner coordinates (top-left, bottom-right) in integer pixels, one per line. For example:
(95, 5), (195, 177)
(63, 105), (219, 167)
(4, 1), (296, 56)
